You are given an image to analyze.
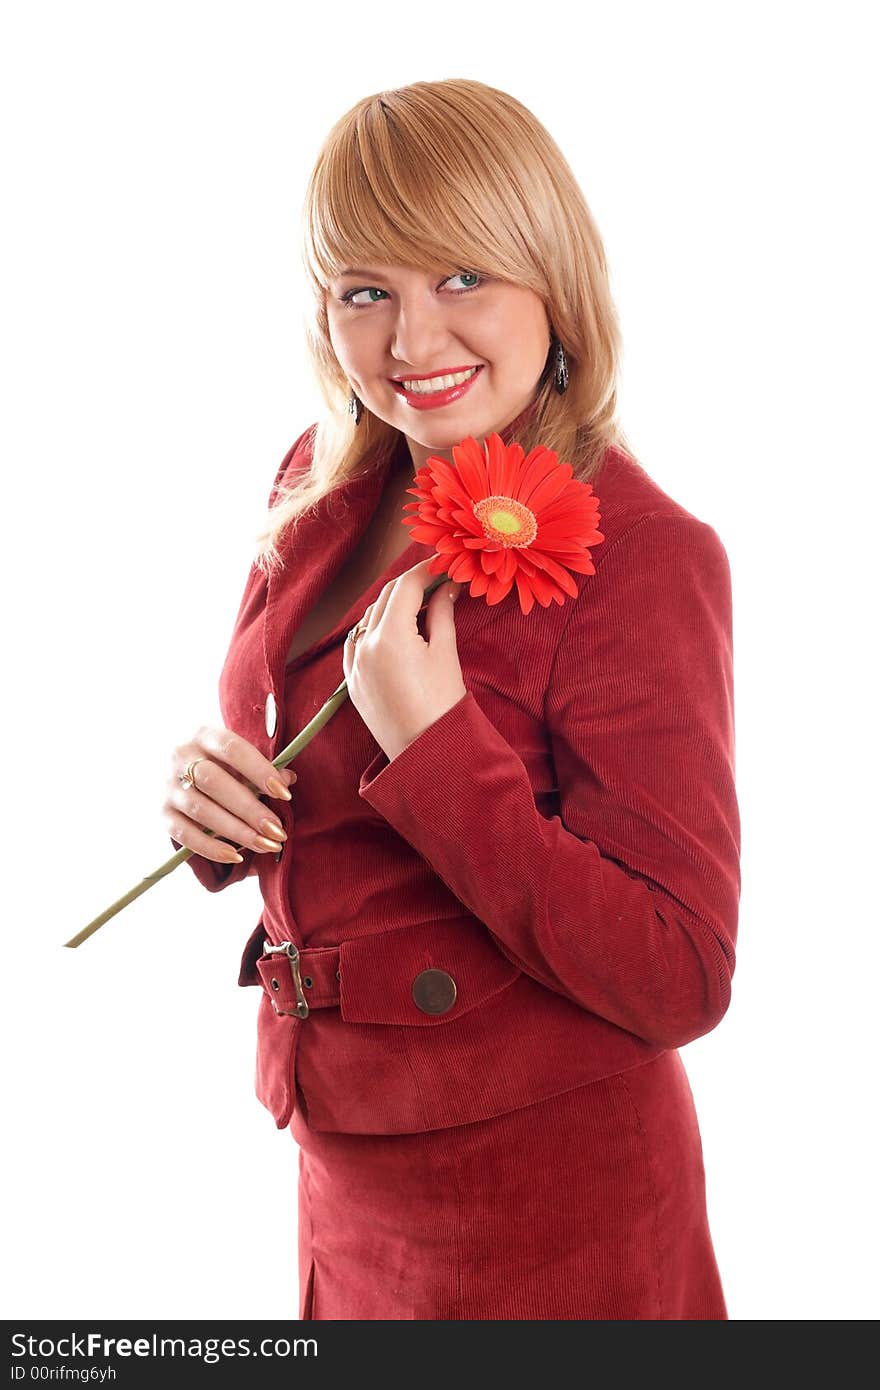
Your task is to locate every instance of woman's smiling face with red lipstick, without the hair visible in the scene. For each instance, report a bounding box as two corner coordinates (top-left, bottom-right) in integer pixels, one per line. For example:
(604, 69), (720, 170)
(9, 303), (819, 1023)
(325, 265), (551, 468)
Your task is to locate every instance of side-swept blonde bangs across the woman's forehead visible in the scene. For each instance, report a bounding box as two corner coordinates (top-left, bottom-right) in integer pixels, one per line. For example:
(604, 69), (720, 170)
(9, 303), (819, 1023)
(303, 89), (544, 289)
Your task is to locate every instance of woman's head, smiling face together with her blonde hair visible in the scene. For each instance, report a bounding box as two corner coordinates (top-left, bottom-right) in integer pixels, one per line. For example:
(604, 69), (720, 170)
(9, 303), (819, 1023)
(251, 78), (633, 571)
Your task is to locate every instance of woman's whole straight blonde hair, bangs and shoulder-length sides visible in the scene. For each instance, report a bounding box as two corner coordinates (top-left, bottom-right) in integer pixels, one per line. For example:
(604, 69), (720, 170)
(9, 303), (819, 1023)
(254, 78), (631, 570)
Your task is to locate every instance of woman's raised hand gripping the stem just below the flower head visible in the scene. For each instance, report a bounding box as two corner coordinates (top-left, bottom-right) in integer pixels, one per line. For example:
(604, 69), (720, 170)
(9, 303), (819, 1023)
(342, 556), (467, 760)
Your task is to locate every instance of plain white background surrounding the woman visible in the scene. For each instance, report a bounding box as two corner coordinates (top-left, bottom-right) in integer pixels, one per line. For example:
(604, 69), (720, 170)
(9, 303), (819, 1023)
(0, 0), (880, 1319)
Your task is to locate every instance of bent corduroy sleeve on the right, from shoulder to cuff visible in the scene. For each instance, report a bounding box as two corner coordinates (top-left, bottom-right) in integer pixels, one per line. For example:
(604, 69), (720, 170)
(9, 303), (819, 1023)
(353, 514), (740, 1048)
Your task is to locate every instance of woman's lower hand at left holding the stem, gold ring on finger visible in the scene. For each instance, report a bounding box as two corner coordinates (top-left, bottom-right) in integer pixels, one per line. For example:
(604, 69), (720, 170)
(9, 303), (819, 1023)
(163, 726), (296, 865)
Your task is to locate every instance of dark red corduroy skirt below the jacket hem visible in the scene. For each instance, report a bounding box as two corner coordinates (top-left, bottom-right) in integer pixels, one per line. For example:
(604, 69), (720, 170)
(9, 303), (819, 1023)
(291, 1051), (727, 1321)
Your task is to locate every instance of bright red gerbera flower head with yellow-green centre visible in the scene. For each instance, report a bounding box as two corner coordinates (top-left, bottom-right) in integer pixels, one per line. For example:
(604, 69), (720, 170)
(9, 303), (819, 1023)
(403, 434), (605, 613)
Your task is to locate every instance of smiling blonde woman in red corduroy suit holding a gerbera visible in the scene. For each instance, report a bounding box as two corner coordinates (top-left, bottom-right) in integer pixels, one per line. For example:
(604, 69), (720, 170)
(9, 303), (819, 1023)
(170, 79), (740, 1319)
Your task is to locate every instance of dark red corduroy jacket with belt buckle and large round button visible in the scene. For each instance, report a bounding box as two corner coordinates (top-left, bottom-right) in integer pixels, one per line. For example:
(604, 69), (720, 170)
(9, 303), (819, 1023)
(175, 427), (740, 1133)
